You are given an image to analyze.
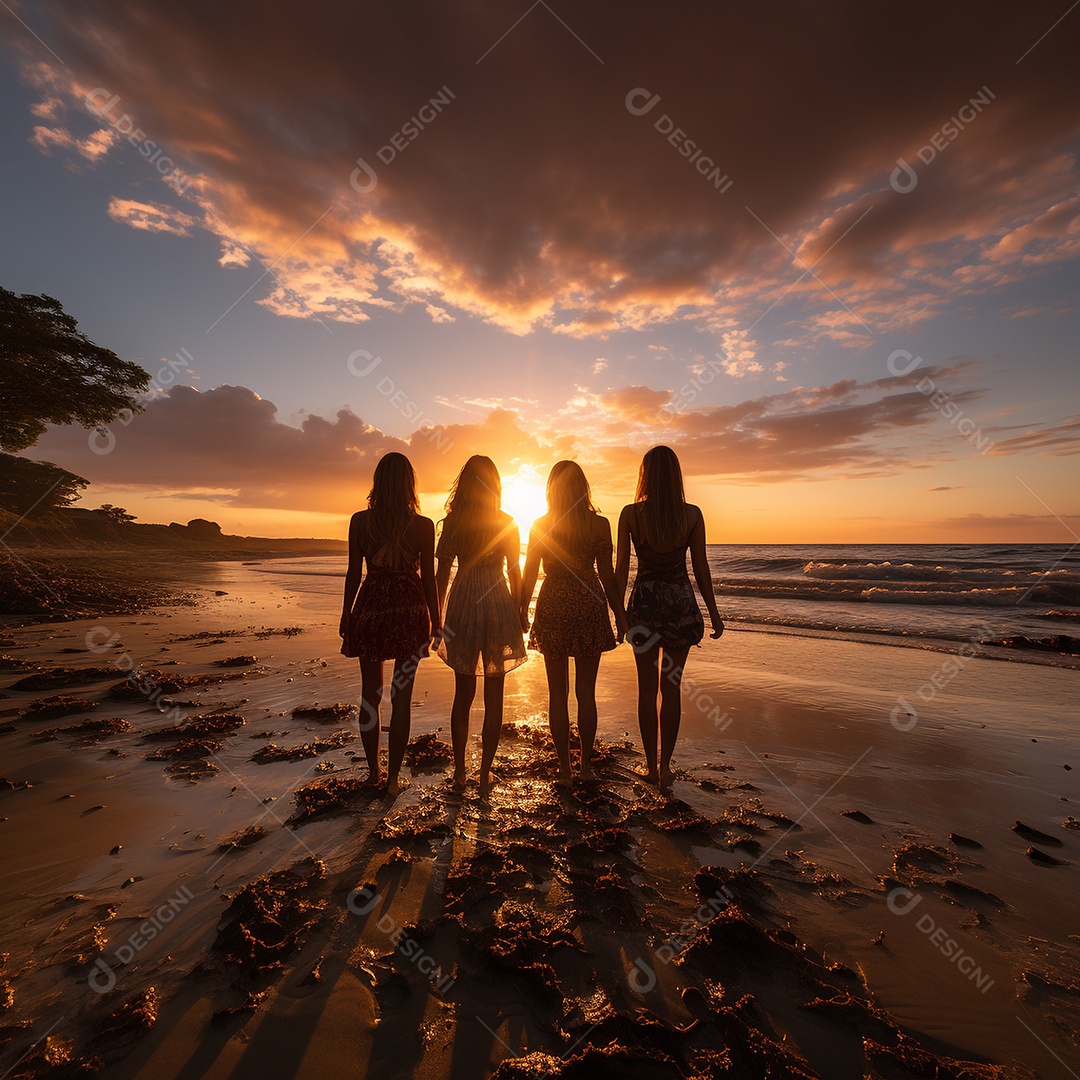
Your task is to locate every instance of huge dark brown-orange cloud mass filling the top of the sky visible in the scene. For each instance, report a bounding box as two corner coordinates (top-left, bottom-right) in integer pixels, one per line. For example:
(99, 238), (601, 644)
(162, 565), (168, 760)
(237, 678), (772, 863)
(14, 0), (1080, 334)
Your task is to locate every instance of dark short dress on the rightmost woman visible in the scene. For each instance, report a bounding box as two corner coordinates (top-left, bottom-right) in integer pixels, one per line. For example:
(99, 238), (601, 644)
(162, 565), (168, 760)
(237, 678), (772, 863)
(626, 514), (705, 649)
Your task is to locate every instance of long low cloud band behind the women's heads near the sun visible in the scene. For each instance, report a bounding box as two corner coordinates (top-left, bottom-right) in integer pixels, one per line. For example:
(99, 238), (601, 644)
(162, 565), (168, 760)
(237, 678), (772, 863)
(25, 361), (1080, 513)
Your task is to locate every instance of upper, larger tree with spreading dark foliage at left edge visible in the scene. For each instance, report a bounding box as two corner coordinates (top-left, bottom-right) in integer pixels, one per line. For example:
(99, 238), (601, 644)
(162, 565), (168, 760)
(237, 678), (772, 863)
(0, 288), (150, 451)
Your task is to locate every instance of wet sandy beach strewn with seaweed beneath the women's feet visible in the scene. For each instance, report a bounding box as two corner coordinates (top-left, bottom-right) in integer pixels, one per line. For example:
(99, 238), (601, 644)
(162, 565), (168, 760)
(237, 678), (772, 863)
(0, 558), (1080, 1080)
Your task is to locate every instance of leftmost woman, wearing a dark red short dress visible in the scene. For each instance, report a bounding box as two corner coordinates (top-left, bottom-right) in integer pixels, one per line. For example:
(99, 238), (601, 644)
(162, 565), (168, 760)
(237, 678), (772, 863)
(338, 454), (438, 796)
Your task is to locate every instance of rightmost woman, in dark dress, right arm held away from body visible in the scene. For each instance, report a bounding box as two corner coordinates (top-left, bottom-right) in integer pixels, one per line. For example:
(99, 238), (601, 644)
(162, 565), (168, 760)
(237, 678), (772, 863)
(616, 446), (724, 788)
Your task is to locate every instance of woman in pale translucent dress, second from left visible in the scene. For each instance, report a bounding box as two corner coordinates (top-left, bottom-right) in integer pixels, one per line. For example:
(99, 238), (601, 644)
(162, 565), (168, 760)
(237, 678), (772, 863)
(436, 454), (527, 799)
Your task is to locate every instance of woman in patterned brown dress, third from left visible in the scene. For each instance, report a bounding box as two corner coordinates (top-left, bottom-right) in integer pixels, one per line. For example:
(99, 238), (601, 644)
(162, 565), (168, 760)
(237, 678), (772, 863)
(519, 461), (626, 786)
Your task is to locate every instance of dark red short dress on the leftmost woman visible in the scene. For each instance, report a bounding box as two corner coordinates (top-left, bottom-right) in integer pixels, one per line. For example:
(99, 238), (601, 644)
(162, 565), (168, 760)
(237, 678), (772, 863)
(341, 556), (431, 661)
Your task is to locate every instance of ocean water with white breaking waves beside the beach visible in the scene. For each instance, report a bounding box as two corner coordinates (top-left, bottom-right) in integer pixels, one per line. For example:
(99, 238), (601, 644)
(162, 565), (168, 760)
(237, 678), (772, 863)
(245, 544), (1080, 667)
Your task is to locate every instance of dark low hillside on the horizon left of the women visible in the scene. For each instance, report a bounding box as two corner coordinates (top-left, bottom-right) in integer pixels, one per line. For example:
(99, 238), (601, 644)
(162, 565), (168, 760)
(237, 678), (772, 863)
(0, 507), (347, 558)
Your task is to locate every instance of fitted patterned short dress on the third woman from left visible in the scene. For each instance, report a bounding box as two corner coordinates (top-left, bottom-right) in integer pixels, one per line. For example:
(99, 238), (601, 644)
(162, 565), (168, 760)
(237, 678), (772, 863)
(529, 538), (615, 659)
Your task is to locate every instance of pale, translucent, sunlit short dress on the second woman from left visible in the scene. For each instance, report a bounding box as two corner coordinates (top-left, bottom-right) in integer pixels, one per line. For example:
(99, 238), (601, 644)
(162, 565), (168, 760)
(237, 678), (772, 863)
(437, 541), (528, 678)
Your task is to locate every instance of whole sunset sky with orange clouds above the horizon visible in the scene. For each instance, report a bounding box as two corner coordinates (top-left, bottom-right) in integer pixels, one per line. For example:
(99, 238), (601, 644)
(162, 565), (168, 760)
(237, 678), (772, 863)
(0, 0), (1080, 543)
